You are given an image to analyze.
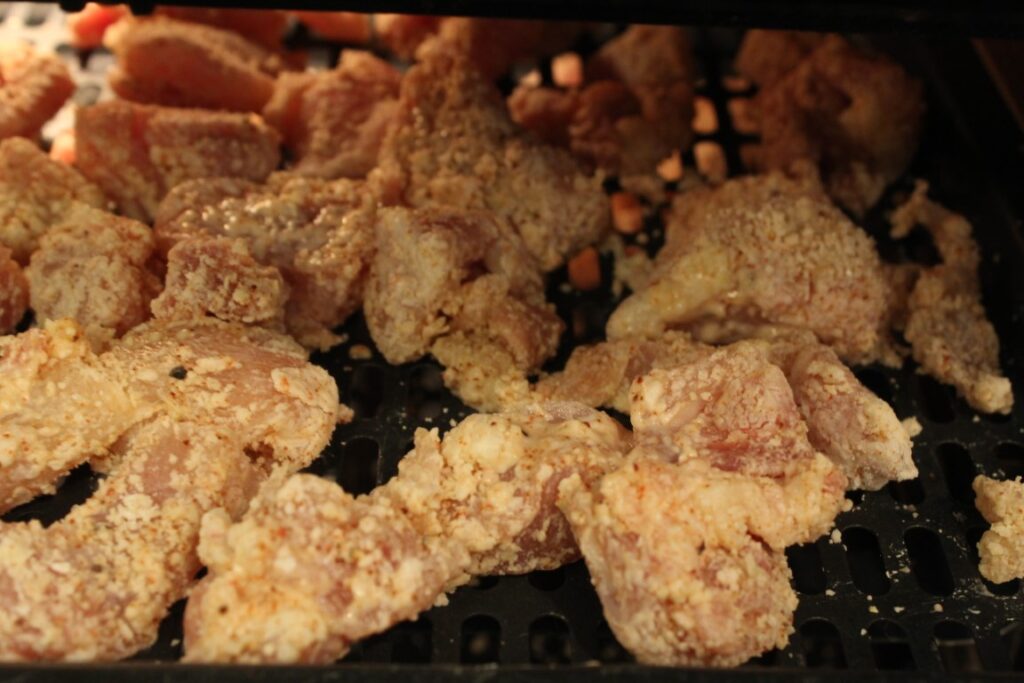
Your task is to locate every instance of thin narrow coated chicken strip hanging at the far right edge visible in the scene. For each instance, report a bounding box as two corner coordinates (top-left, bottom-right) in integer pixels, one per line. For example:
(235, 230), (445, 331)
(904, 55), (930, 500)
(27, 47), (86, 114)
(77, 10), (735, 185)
(892, 181), (1014, 414)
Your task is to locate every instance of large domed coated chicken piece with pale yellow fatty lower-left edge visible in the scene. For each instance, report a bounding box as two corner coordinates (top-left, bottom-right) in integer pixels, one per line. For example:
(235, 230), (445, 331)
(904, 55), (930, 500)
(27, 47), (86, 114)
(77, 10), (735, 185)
(607, 167), (895, 362)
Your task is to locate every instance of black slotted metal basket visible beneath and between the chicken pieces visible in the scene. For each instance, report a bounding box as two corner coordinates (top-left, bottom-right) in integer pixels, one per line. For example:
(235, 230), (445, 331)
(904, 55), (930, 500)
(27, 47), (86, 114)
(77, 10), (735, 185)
(0, 2), (1024, 681)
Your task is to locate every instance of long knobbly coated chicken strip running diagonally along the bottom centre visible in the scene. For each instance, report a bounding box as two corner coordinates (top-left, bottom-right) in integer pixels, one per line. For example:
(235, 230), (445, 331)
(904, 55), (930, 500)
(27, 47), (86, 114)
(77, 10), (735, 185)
(185, 403), (630, 663)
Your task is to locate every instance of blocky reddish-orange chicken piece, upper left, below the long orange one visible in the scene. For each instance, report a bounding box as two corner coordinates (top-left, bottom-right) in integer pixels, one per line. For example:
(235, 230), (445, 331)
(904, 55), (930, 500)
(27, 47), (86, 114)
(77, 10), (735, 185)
(75, 101), (281, 221)
